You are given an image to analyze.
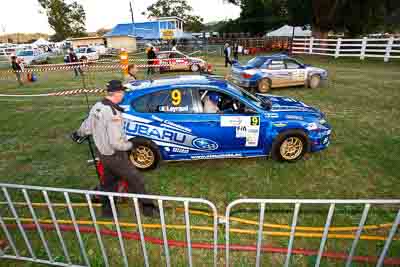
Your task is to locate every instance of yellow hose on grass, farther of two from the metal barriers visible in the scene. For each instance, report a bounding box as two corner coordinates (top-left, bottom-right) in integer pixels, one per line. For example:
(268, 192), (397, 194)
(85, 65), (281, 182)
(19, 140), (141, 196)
(0, 202), (392, 232)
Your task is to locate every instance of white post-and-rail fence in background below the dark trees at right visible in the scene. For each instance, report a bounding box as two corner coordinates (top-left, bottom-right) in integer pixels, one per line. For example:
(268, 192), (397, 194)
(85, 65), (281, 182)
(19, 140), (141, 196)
(292, 37), (400, 62)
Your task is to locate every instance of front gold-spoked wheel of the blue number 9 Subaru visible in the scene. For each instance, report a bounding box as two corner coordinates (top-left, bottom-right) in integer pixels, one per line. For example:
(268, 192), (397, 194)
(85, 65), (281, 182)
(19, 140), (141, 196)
(271, 130), (308, 162)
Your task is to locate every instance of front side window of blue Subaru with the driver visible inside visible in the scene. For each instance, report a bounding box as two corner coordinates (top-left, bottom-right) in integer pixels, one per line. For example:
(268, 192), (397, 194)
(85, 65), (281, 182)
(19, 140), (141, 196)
(196, 88), (255, 114)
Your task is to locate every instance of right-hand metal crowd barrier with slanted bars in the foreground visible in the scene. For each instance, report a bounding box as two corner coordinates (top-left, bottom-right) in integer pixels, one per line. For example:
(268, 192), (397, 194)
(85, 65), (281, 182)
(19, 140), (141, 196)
(225, 199), (400, 267)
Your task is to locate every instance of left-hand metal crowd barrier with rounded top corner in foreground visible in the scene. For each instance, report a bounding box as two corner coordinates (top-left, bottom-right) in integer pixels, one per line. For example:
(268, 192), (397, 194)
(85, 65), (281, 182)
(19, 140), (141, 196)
(0, 183), (218, 267)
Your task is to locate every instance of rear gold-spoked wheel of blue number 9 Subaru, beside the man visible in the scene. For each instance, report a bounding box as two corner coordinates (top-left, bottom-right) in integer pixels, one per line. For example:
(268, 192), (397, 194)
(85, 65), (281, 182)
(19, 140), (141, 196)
(129, 137), (161, 171)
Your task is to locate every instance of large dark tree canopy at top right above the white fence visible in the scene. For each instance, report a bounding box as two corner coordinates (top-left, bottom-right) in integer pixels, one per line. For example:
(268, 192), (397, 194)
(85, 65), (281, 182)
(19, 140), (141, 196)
(226, 0), (400, 39)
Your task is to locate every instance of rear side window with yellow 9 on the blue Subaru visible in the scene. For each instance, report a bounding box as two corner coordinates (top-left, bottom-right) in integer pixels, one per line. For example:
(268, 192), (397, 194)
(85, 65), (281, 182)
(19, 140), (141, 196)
(132, 88), (194, 113)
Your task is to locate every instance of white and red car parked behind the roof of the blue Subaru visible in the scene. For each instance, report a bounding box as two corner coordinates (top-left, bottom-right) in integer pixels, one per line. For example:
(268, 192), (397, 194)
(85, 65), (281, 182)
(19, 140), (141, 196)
(155, 51), (207, 72)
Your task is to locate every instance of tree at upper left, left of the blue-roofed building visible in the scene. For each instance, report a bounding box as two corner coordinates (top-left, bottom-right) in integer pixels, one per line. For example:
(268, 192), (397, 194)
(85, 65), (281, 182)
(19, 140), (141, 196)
(38, 0), (86, 41)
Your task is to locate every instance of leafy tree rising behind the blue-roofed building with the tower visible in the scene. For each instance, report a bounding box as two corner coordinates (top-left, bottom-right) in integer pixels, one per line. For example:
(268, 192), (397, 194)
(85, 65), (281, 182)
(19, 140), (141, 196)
(143, 0), (204, 32)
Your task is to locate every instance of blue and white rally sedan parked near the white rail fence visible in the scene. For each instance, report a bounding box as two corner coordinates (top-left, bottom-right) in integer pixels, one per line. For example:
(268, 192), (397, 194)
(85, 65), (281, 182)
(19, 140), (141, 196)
(231, 54), (328, 93)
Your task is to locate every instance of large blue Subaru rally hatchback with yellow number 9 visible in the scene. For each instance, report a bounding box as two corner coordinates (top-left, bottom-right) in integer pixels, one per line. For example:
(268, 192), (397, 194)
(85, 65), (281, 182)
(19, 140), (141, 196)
(121, 76), (331, 170)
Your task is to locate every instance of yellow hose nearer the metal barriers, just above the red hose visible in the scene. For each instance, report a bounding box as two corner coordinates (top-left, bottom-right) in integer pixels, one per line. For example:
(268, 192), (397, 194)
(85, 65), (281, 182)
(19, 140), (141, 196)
(3, 217), (400, 241)
